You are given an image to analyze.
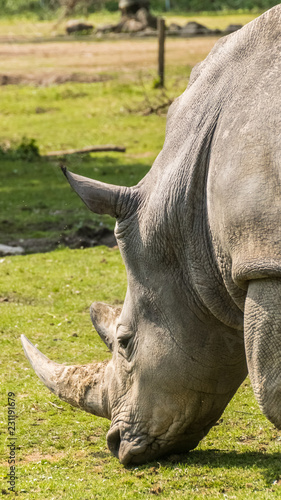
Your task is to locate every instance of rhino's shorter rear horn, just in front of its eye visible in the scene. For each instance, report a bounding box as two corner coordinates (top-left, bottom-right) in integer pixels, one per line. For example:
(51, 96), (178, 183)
(90, 302), (122, 351)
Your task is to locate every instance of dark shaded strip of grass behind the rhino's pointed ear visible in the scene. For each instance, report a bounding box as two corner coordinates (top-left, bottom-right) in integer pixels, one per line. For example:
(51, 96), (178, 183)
(0, 154), (150, 244)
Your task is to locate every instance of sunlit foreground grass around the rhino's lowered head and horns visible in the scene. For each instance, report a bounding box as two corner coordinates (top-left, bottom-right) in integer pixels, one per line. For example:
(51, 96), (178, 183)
(0, 247), (281, 500)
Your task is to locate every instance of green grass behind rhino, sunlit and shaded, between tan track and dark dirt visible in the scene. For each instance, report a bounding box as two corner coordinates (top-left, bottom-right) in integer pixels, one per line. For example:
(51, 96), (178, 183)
(0, 78), (184, 243)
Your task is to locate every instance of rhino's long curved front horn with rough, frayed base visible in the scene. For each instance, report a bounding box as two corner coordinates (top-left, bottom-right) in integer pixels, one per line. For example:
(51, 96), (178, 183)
(21, 335), (110, 419)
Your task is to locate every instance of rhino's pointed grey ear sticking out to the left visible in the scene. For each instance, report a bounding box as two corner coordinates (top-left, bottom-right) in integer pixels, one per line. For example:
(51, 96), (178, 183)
(61, 167), (130, 217)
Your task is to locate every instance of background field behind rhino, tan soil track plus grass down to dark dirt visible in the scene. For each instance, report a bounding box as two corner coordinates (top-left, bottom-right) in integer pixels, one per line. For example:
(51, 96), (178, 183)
(0, 38), (219, 243)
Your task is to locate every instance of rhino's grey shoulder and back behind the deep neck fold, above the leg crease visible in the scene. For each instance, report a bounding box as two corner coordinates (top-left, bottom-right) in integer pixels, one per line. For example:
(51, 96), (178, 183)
(208, 6), (281, 309)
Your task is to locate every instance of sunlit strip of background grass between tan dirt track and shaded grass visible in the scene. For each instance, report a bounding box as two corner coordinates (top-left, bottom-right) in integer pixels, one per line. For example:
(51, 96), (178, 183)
(0, 81), (171, 154)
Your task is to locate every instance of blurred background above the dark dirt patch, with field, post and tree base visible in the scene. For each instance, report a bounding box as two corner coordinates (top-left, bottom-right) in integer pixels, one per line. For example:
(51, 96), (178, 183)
(0, 0), (276, 253)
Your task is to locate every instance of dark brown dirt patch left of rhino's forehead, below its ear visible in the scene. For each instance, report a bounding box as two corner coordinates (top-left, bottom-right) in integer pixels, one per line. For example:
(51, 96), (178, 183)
(9, 226), (117, 254)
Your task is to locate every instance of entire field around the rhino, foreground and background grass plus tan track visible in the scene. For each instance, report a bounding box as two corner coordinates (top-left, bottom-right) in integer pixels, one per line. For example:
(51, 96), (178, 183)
(0, 11), (281, 500)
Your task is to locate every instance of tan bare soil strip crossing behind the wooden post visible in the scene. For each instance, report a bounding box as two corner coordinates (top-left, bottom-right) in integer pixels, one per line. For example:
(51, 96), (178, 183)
(0, 37), (218, 85)
